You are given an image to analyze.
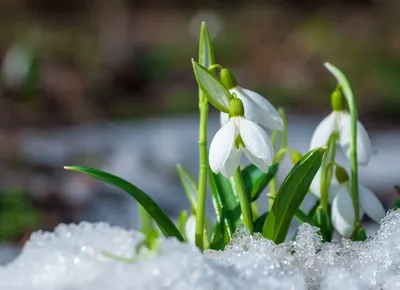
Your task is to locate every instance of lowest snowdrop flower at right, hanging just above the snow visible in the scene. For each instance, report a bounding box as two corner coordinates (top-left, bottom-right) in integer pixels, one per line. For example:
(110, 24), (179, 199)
(310, 166), (386, 238)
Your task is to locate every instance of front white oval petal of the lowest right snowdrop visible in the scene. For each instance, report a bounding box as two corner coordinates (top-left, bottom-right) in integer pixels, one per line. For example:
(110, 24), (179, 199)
(332, 187), (354, 238)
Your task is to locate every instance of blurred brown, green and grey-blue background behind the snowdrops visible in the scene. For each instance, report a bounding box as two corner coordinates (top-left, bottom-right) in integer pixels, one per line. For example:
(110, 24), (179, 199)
(0, 0), (400, 263)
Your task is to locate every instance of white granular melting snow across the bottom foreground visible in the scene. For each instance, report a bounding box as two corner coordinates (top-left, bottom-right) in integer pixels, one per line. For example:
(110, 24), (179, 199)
(0, 210), (400, 290)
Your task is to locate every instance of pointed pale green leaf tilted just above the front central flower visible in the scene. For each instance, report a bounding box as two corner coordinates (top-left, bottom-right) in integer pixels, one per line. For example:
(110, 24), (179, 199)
(192, 59), (232, 113)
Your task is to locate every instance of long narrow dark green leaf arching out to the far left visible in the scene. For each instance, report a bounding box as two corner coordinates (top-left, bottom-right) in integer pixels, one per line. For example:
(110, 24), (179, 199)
(64, 166), (184, 241)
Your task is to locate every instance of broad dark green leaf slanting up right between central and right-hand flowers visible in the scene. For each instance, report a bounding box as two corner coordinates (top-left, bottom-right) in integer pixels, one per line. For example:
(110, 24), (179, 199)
(263, 147), (326, 243)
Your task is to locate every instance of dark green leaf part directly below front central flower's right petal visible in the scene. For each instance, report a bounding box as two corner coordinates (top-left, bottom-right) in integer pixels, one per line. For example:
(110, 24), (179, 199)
(242, 163), (279, 201)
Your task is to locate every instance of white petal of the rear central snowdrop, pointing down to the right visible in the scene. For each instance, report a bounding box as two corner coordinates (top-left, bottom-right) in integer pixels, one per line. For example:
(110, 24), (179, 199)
(230, 87), (283, 130)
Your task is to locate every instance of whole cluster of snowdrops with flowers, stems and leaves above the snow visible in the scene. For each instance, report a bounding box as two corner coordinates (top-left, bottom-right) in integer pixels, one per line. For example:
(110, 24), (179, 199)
(66, 23), (385, 254)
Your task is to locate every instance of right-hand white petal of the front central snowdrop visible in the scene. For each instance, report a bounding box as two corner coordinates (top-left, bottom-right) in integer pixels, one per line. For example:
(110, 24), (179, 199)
(239, 118), (274, 171)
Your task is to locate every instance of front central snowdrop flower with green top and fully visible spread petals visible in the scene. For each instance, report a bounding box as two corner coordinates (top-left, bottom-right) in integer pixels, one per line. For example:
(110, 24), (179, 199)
(209, 95), (274, 178)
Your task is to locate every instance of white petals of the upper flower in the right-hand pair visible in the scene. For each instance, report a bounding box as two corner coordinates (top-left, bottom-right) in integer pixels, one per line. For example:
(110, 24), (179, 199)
(310, 111), (372, 165)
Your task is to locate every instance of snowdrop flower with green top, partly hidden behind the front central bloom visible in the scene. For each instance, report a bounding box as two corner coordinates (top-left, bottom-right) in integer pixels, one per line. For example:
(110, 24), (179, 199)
(220, 68), (283, 130)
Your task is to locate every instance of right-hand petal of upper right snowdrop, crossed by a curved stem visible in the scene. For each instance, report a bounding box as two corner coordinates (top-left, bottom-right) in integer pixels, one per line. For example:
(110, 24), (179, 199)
(340, 112), (372, 165)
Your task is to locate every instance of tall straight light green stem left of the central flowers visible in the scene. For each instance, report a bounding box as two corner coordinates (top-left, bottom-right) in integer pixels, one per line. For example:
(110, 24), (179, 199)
(195, 99), (208, 251)
